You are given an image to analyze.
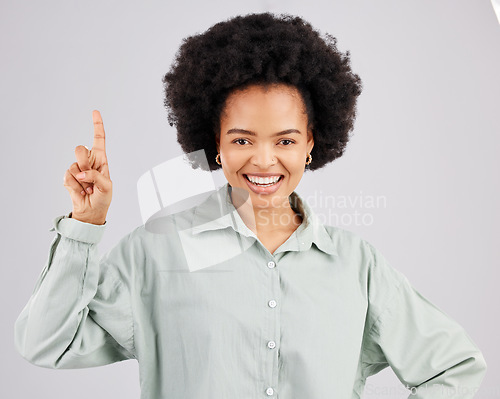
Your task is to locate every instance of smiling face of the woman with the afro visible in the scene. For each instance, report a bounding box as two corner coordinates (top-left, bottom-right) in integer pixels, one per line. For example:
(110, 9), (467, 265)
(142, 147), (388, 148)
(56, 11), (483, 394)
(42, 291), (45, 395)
(218, 85), (314, 208)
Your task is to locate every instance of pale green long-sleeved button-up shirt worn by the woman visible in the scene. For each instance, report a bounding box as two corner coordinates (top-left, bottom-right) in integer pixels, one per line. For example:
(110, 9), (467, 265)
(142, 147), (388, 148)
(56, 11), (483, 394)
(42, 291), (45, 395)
(15, 184), (486, 399)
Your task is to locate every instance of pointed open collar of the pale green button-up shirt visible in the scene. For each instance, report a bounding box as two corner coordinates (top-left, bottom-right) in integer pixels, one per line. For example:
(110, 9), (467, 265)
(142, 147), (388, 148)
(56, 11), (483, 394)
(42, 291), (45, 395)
(192, 183), (337, 255)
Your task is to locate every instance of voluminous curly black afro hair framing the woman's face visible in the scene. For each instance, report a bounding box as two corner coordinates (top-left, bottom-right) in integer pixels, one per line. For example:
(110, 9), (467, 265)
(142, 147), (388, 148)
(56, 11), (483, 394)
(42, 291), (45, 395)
(163, 13), (362, 170)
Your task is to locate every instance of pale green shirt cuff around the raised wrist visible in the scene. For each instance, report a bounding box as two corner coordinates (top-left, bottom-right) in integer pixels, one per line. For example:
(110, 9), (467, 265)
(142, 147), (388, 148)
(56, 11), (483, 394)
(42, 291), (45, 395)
(49, 212), (106, 244)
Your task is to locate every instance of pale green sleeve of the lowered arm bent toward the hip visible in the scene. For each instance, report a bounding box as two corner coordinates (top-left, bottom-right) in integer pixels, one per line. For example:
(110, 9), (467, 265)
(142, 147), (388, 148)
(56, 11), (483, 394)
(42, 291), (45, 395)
(363, 242), (486, 399)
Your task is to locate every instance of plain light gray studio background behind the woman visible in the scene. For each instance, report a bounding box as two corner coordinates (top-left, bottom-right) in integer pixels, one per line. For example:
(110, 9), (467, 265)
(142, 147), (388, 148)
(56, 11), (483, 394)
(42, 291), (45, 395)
(0, 0), (500, 399)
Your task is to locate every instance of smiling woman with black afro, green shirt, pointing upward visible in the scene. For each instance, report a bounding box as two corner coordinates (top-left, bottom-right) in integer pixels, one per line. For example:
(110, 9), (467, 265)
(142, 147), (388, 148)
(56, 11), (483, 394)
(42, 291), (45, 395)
(16, 13), (486, 399)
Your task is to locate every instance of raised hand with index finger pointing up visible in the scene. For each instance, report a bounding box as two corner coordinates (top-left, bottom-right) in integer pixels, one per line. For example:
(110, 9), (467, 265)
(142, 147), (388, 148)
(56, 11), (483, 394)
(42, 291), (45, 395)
(64, 111), (113, 224)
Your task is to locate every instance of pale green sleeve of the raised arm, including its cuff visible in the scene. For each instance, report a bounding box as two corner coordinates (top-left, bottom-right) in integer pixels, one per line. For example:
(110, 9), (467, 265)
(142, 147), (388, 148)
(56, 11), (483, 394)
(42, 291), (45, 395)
(15, 216), (134, 368)
